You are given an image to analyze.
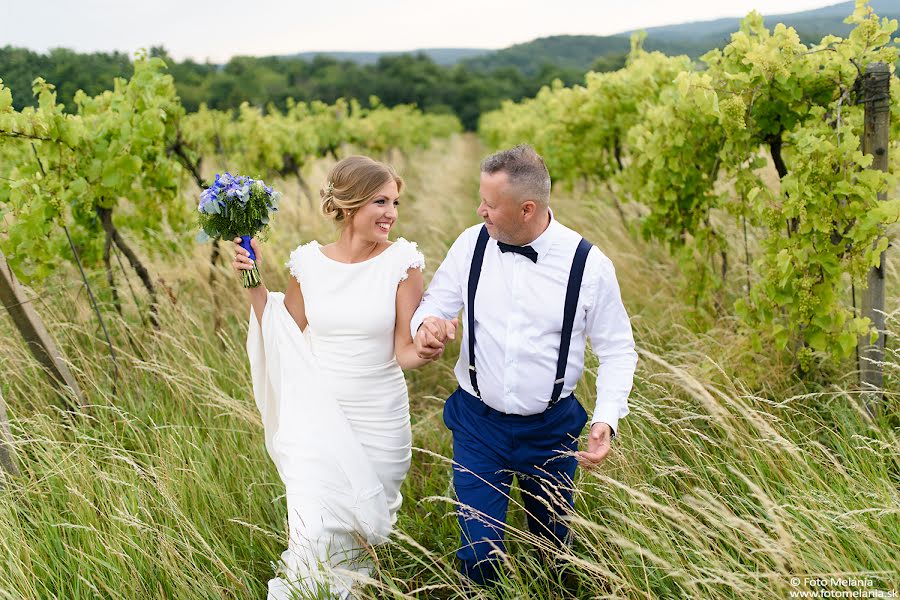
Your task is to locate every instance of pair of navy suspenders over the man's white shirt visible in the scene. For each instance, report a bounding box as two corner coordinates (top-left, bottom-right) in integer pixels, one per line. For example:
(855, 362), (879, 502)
(466, 227), (591, 406)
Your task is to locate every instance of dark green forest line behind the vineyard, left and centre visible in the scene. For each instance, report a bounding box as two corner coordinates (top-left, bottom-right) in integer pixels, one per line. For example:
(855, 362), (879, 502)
(0, 46), (612, 130)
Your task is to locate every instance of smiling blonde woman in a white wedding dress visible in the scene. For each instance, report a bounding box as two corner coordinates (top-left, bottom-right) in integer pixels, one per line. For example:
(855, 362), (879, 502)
(232, 156), (444, 600)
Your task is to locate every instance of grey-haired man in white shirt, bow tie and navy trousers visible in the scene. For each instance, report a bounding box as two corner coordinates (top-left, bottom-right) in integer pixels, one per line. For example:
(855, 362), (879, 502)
(410, 145), (637, 584)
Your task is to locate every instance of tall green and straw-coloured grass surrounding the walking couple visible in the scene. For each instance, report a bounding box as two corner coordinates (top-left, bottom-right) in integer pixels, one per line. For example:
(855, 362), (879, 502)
(0, 137), (900, 599)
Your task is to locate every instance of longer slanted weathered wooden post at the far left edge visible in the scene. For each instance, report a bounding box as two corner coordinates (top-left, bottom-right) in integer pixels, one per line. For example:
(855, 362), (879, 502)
(0, 252), (84, 404)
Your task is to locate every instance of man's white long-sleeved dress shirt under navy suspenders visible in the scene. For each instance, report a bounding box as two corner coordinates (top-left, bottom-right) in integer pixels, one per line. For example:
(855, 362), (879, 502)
(410, 215), (637, 432)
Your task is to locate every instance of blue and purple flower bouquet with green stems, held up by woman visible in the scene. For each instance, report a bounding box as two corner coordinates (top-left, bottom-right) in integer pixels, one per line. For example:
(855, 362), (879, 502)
(197, 173), (281, 288)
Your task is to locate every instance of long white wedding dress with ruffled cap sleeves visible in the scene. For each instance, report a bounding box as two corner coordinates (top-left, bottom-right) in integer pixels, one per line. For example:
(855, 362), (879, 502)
(247, 238), (425, 600)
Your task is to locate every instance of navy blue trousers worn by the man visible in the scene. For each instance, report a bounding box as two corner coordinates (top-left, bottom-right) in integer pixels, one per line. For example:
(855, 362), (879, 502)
(444, 388), (587, 585)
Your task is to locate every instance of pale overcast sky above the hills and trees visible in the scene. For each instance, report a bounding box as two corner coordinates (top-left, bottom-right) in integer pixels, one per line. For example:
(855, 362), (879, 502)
(0, 0), (834, 62)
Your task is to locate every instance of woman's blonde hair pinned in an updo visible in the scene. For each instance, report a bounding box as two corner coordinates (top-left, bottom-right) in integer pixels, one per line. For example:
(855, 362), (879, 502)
(319, 156), (403, 227)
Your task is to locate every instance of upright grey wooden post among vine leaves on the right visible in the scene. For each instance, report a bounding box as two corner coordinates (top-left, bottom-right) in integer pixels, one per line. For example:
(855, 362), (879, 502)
(859, 62), (891, 417)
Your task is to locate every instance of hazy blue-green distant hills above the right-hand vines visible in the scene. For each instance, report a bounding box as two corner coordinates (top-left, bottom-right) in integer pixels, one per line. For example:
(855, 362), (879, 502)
(463, 0), (900, 75)
